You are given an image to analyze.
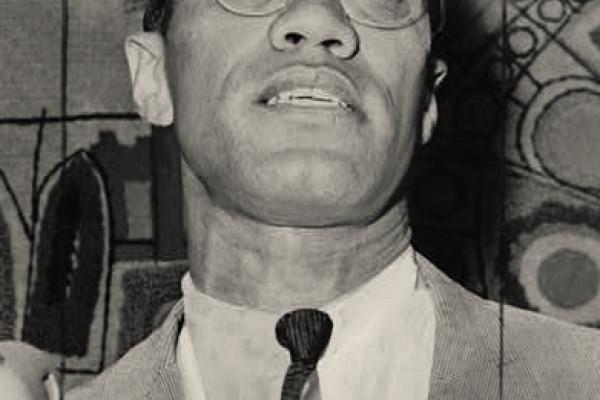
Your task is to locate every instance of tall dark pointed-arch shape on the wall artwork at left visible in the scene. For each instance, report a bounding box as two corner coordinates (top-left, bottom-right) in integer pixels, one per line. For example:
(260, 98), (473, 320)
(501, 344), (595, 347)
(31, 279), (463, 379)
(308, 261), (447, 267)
(23, 151), (109, 357)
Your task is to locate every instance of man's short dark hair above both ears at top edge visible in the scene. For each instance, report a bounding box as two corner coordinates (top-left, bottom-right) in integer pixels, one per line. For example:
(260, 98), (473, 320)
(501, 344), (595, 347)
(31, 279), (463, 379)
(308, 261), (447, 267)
(139, 0), (444, 35)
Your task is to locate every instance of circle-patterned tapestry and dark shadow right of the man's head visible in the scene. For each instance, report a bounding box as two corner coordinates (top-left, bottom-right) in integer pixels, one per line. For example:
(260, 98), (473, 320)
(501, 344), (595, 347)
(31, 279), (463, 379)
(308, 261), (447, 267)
(413, 0), (600, 327)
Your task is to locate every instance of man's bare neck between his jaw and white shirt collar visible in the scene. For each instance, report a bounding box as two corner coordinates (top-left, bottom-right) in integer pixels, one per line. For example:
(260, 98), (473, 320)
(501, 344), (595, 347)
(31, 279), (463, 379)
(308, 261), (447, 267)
(183, 162), (410, 313)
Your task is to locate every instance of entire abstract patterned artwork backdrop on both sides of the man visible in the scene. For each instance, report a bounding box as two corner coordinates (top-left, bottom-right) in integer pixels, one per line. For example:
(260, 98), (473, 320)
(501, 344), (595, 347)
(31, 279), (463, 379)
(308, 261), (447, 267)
(0, 0), (600, 387)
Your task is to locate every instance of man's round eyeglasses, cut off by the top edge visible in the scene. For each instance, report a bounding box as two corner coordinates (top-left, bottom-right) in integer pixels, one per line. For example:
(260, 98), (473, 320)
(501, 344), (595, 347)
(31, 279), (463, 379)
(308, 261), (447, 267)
(216, 0), (441, 32)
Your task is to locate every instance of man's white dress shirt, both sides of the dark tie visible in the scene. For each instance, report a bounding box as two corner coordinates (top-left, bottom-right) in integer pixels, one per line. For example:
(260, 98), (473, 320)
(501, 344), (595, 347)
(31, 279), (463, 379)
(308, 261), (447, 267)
(178, 246), (435, 400)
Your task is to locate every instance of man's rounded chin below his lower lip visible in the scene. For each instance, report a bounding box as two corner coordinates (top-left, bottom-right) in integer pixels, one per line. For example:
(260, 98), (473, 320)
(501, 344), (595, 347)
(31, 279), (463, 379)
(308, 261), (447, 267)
(230, 156), (384, 227)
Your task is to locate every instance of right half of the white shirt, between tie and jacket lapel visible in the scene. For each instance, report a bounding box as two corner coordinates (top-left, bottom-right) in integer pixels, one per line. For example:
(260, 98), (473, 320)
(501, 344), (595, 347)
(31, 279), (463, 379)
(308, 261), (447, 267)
(317, 247), (436, 400)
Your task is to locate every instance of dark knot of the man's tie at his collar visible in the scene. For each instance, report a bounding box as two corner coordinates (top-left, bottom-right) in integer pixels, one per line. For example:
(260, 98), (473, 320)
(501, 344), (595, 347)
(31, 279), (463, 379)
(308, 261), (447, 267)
(275, 309), (333, 364)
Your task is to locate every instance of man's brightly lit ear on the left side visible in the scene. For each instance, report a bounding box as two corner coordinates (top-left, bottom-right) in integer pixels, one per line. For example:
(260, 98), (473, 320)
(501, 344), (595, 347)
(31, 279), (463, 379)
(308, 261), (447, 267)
(125, 32), (173, 126)
